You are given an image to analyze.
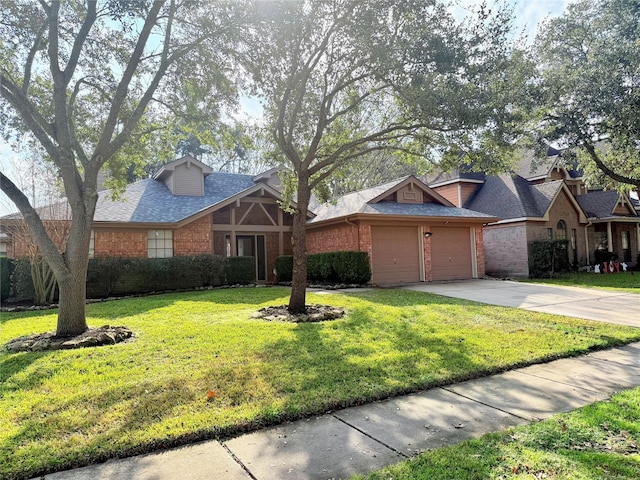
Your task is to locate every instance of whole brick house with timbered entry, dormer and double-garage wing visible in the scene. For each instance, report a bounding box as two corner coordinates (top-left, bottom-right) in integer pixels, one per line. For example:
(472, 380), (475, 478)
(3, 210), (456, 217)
(2, 157), (496, 283)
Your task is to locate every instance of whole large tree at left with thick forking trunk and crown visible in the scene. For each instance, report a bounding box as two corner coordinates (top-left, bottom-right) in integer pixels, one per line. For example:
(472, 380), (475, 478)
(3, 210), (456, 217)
(0, 0), (238, 336)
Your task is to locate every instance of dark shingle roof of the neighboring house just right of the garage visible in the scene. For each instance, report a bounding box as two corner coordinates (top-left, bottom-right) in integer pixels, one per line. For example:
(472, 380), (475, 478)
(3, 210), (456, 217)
(465, 174), (562, 220)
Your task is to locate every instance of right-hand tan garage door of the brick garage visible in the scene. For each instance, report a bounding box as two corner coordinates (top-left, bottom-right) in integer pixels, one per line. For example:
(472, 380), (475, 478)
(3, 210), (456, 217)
(430, 227), (473, 281)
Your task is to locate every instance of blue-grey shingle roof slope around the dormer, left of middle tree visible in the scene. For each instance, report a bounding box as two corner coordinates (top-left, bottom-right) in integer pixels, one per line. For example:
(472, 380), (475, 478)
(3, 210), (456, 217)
(94, 172), (256, 223)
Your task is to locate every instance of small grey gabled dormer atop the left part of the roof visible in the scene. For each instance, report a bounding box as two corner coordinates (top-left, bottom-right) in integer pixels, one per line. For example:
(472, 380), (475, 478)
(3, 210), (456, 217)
(153, 155), (213, 197)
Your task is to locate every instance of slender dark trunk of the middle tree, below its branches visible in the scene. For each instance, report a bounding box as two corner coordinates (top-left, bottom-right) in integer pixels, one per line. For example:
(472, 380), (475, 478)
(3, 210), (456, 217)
(288, 178), (311, 314)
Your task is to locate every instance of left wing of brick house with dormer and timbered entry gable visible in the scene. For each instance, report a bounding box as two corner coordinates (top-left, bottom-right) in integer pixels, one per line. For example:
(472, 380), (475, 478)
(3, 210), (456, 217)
(2, 157), (293, 281)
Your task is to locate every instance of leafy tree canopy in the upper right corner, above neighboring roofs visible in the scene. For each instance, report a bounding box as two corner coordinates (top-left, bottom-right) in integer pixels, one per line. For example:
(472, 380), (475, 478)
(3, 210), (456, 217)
(534, 0), (640, 189)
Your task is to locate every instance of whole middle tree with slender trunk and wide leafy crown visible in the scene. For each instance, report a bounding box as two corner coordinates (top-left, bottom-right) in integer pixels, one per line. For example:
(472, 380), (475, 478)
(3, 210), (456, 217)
(242, 0), (527, 312)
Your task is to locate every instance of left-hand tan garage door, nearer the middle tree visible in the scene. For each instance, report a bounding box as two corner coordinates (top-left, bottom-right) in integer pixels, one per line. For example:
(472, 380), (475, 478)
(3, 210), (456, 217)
(371, 226), (422, 284)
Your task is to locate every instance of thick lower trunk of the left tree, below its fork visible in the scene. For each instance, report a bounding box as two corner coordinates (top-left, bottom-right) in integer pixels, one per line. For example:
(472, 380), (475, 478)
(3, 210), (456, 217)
(56, 269), (88, 337)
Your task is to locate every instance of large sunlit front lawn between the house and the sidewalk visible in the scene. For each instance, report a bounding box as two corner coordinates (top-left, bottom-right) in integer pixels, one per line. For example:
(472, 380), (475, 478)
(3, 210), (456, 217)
(0, 288), (640, 478)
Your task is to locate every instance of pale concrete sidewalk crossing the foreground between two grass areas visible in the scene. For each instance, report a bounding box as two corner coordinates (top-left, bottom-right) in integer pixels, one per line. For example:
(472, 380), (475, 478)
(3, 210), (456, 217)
(38, 342), (640, 480)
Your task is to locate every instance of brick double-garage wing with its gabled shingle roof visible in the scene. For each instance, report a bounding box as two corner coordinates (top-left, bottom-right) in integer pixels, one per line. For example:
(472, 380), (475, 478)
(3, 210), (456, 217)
(307, 176), (497, 284)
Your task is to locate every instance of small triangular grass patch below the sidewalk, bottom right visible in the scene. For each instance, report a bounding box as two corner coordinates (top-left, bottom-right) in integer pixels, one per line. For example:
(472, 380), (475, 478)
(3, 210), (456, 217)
(354, 388), (640, 480)
